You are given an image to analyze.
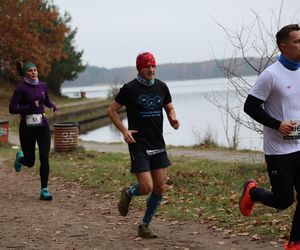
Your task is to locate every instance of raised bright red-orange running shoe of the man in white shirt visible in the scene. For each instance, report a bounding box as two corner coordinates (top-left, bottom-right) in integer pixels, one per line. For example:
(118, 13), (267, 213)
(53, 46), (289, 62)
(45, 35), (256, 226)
(239, 179), (257, 216)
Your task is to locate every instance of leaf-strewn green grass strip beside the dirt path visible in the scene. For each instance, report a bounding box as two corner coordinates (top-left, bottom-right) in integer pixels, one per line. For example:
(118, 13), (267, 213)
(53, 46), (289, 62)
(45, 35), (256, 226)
(0, 147), (294, 240)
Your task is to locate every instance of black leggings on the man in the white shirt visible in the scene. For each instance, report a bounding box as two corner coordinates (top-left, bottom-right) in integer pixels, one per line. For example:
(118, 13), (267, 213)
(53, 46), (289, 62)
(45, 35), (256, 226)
(250, 152), (300, 241)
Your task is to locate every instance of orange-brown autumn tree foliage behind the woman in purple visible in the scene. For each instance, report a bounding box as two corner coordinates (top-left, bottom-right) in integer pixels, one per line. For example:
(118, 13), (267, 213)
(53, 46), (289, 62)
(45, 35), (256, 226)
(0, 0), (69, 80)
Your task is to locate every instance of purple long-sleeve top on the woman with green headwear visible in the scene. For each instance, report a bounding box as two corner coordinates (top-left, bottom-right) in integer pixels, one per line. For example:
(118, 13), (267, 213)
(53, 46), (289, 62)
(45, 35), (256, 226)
(9, 81), (57, 125)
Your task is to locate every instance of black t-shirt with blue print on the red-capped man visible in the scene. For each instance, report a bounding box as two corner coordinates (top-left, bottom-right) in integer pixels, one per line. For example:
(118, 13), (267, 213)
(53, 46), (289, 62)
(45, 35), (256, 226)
(115, 79), (172, 150)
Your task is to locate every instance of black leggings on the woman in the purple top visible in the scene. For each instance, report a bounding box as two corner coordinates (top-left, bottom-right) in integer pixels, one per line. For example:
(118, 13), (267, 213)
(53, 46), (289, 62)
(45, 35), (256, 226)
(19, 120), (51, 188)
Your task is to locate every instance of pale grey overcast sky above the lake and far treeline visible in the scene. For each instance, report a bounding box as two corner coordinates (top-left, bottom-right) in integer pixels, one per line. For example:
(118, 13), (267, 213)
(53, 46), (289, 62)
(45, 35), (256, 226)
(53, 0), (300, 68)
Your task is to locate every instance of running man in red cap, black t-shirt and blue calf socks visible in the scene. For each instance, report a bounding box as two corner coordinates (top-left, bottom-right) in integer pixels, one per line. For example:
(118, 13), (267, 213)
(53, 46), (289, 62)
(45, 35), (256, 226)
(107, 52), (179, 238)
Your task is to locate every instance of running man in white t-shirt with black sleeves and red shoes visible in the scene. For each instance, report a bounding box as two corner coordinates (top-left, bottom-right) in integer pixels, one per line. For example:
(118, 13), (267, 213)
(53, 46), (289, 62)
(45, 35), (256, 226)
(239, 24), (300, 250)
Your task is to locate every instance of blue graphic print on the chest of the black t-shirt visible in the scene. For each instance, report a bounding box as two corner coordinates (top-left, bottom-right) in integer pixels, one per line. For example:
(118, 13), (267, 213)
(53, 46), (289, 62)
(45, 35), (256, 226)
(138, 94), (162, 117)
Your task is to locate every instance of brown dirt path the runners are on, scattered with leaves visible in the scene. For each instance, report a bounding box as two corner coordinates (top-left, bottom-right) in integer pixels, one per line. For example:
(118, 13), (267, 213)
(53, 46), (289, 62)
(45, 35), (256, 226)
(0, 154), (274, 250)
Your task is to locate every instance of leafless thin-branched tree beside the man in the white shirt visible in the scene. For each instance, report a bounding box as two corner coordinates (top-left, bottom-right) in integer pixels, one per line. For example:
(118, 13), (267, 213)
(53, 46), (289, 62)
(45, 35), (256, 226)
(208, 0), (297, 139)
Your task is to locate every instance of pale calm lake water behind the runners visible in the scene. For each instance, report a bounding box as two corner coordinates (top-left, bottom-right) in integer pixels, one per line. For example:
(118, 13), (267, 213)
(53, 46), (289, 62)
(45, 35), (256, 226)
(62, 77), (262, 150)
